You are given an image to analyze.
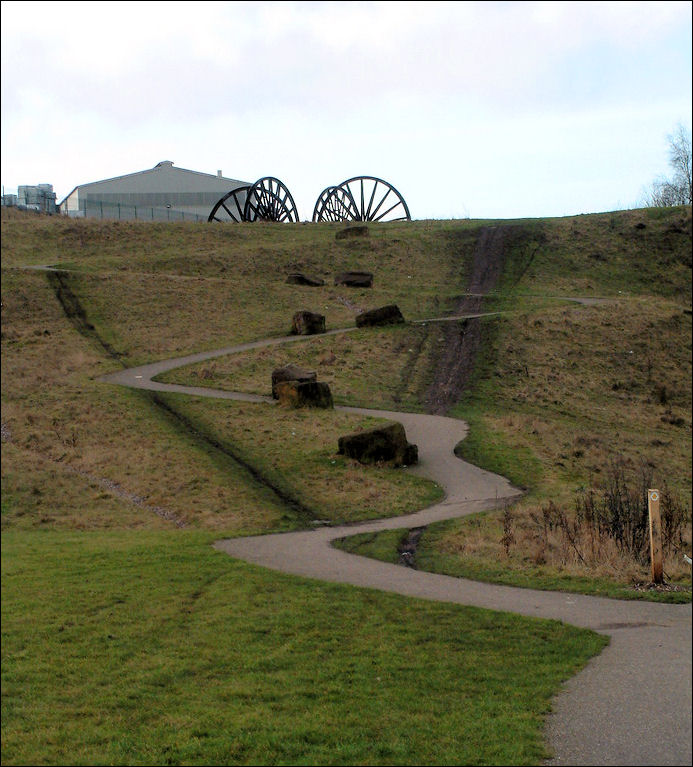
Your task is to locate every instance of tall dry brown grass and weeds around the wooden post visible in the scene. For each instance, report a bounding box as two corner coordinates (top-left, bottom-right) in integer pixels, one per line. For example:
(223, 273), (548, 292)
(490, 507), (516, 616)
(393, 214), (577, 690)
(424, 467), (690, 602)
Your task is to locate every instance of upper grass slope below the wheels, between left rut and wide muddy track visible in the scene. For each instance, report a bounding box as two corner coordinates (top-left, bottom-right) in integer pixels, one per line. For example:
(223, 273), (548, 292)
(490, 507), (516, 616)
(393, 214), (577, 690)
(3, 217), (478, 364)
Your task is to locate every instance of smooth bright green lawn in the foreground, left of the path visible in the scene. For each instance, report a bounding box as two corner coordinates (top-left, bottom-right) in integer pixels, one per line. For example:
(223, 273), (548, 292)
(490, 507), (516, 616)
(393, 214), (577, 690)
(2, 531), (607, 765)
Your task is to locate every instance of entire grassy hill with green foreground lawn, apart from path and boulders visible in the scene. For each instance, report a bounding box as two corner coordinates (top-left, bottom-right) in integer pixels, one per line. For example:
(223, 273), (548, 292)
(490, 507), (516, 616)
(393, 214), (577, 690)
(2, 208), (691, 764)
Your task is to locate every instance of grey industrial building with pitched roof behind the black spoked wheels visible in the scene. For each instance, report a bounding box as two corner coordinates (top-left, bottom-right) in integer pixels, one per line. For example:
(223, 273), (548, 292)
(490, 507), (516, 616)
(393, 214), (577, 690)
(60, 160), (248, 221)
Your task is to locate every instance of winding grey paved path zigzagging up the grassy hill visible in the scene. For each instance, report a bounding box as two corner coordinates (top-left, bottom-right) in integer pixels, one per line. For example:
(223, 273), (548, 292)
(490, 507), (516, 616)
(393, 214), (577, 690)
(102, 318), (691, 765)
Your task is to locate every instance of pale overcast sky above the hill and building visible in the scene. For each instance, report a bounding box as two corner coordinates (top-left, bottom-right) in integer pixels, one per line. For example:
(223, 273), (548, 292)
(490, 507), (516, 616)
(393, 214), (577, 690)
(1, 0), (692, 220)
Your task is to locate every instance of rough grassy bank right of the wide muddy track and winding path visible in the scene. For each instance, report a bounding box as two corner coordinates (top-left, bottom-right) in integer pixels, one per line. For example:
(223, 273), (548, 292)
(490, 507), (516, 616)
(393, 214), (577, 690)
(332, 208), (691, 601)
